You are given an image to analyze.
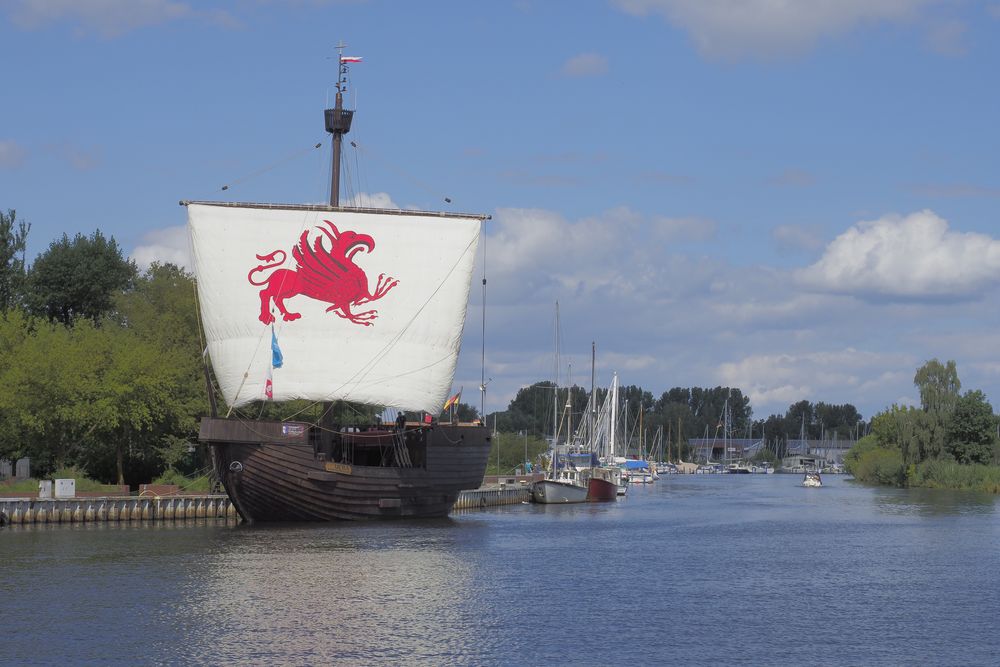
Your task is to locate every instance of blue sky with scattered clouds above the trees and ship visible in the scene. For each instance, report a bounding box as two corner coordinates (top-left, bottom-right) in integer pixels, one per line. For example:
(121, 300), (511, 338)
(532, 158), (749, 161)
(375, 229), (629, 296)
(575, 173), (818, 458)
(0, 0), (1000, 417)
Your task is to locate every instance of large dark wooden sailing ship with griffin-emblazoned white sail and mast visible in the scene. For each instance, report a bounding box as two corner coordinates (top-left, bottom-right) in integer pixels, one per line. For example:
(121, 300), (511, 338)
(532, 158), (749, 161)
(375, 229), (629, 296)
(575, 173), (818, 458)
(181, 52), (491, 522)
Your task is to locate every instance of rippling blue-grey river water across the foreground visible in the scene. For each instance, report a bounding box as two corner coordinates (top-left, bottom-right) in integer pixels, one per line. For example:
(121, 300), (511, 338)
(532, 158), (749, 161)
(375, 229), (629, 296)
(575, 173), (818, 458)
(0, 475), (1000, 665)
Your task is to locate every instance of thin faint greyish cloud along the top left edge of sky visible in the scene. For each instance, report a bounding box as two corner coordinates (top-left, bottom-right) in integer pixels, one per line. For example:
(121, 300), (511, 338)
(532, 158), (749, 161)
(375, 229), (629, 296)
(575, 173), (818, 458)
(6, 0), (235, 38)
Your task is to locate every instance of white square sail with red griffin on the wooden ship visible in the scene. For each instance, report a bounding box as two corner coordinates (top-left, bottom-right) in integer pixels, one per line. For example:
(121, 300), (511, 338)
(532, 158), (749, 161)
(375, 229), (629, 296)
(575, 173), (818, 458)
(187, 202), (485, 413)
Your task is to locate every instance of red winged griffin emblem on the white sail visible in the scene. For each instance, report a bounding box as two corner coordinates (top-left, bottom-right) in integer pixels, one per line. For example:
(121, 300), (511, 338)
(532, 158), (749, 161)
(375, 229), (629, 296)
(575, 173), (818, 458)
(247, 220), (399, 327)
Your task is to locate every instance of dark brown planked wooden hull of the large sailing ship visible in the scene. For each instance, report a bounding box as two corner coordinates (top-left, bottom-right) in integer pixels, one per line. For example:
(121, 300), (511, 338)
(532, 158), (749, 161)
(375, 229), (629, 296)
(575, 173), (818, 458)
(200, 418), (490, 522)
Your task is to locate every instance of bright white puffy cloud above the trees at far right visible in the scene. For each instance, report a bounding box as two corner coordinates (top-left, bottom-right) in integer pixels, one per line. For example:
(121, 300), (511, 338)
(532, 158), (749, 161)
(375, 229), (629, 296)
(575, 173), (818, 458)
(796, 210), (1000, 299)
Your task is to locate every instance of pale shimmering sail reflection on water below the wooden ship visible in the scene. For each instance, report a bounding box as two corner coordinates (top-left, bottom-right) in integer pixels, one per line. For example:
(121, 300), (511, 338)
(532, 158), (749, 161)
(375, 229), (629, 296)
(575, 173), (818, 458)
(177, 521), (488, 664)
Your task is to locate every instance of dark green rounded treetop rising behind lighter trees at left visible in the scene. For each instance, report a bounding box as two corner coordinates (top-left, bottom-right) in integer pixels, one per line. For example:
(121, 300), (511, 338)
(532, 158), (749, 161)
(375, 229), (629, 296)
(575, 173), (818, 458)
(25, 231), (137, 326)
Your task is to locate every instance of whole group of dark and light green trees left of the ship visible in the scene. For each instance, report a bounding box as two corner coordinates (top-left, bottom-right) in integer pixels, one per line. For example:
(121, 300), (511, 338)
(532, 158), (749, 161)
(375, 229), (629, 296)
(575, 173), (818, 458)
(0, 210), (208, 483)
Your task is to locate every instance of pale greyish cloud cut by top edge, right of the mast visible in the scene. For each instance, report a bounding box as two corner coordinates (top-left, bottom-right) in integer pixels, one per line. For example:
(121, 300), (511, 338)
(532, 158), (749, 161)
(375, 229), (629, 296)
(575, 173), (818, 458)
(616, 0), (940, 59)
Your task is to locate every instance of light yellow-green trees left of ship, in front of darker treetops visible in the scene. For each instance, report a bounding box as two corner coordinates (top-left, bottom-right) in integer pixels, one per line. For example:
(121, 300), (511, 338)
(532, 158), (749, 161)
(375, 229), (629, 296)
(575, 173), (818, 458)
(0, 267), (207, 483)
